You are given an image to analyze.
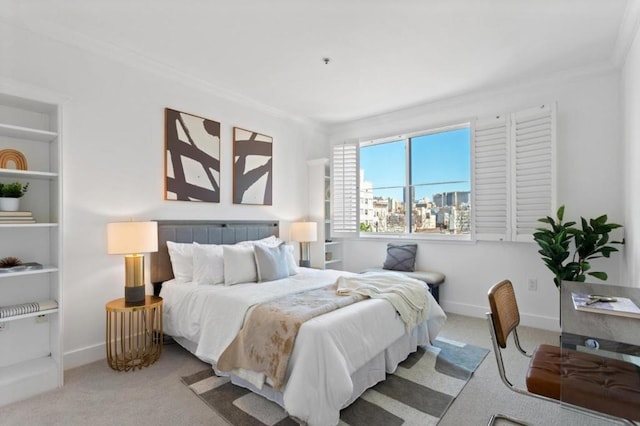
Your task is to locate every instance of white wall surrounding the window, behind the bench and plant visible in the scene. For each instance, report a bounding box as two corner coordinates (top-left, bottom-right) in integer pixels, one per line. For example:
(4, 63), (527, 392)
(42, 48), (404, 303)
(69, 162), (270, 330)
(330, 69), (624, 329)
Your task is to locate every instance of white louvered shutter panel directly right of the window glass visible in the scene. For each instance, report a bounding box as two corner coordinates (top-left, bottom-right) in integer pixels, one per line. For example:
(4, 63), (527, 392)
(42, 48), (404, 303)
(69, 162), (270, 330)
(472, 116), (511, 241)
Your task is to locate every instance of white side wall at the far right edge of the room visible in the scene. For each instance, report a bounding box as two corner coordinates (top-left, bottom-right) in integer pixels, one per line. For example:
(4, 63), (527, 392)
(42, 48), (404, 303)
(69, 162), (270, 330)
(622, 20), (640, 287)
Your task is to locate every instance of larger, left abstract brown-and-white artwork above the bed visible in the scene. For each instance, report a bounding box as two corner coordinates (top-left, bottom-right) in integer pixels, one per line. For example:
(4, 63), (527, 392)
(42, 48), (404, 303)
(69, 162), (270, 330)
(164, 108), (220, 203)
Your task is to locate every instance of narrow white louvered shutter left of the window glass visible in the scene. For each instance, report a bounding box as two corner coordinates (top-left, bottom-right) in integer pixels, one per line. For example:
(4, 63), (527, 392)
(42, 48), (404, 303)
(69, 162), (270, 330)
(331, 142), (360, 237)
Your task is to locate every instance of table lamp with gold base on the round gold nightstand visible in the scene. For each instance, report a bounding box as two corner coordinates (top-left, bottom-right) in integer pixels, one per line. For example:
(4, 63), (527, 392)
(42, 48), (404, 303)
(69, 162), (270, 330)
(107, 222), (158, 303)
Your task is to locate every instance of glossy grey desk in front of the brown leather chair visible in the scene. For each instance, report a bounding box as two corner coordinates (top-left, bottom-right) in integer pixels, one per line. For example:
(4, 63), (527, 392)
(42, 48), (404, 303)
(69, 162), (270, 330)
(560, 281), (640, 356)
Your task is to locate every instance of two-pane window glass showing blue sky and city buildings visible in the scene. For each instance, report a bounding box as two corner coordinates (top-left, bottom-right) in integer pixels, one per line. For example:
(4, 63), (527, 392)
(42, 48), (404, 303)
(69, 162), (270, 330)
(359, 123), (471, 234)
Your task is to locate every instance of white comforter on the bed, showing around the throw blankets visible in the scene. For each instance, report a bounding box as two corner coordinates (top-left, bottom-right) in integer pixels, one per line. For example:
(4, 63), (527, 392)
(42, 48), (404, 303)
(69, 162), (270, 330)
(160, 268), (446, 426)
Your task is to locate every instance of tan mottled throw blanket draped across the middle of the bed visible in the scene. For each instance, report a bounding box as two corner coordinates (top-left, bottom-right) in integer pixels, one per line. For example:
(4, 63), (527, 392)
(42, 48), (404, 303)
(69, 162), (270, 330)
(216, 284), (365, 390)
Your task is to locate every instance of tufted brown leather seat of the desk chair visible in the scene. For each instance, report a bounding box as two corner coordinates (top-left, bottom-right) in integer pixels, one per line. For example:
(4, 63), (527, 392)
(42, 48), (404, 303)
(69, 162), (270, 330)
(527, 345), (640, 421)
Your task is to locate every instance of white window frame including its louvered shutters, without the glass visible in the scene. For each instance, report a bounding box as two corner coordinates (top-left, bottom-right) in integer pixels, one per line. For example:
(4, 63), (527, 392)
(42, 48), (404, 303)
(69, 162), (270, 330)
(331, 102), (558, 242)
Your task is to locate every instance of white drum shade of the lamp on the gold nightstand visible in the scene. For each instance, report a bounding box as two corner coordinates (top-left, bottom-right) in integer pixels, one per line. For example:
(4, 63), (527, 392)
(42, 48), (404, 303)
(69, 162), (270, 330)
(107, 222), (158, 254)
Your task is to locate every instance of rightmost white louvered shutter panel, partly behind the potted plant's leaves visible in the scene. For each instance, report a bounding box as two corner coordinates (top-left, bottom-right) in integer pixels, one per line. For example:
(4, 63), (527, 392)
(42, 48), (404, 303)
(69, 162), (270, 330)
(511, 104), (556, 241)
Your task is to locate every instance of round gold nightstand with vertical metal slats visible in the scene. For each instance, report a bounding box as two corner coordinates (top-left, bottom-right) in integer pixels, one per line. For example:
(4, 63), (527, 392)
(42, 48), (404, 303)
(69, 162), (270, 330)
(106, 296), (162, 371)
